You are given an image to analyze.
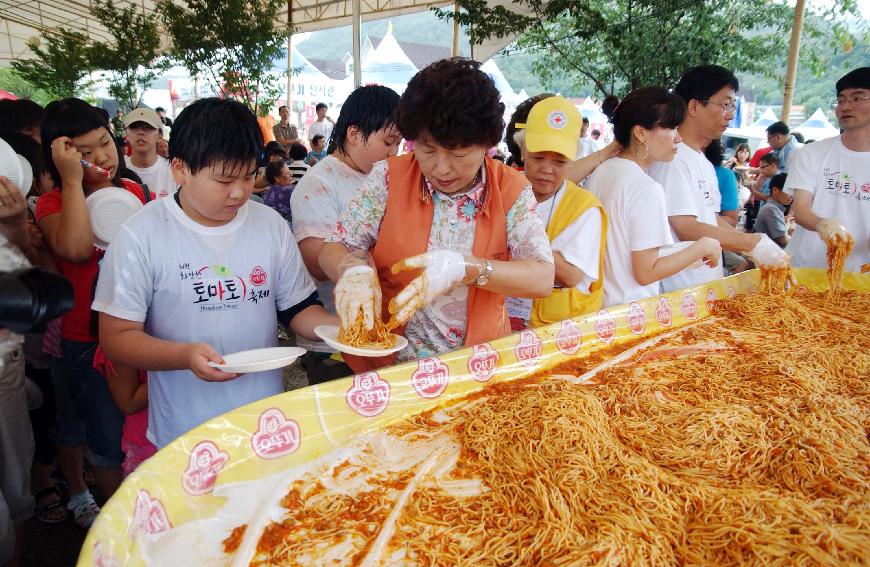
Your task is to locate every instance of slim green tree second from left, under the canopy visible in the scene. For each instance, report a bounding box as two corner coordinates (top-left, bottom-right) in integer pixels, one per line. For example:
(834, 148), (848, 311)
(90, 0), (170, 109)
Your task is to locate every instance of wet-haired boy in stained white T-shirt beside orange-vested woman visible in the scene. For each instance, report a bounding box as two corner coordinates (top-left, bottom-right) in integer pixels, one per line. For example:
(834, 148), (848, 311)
(290, 85), (402, 384)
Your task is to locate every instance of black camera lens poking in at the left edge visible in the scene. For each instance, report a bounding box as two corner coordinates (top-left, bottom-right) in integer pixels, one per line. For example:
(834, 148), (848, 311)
(0, 268), (74, 333)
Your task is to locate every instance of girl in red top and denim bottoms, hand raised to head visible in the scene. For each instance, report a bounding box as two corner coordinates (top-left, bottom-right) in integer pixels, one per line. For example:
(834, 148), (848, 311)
(36, 98), (152, 528)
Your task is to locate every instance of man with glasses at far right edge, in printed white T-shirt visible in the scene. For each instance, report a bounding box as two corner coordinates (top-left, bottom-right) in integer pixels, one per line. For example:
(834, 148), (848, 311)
(784, 67), (870, 272)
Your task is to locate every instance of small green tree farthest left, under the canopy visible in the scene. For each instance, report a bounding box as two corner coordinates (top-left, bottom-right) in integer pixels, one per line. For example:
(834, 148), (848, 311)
(12, 28), (93, 99)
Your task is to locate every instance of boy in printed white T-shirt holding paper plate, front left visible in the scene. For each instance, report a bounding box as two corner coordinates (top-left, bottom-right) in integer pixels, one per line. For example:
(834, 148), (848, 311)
(93, 98), (338, 447)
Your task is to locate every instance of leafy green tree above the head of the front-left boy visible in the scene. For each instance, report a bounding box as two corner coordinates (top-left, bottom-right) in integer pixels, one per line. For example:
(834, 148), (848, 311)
(157, 0), (290, 116)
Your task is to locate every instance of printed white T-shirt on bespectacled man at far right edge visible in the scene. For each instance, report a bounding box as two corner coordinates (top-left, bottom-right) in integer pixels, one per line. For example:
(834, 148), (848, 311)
(785, 136), (870, 272)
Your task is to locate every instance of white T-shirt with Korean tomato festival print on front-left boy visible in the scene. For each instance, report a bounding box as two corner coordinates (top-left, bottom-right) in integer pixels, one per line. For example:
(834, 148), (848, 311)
(93, 199), (314, 447)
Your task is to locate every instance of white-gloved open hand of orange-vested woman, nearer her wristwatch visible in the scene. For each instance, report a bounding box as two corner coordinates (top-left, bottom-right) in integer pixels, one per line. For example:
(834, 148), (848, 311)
(389, 250), (469, 325)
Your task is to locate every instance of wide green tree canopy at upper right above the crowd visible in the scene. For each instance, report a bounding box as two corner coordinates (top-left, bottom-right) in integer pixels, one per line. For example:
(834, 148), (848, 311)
(438, 0), (856, 94)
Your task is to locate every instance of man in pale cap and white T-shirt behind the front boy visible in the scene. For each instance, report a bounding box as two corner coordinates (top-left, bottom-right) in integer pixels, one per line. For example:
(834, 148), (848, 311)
(124, 108), (178, 199)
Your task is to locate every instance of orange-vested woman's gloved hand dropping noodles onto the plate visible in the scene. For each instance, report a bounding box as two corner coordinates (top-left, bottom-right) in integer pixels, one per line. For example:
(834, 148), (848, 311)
(334, 252), (381, 331)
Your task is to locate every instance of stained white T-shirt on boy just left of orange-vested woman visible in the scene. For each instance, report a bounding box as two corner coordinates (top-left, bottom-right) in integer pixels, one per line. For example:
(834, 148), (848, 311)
(290, 155), (367, 352)
